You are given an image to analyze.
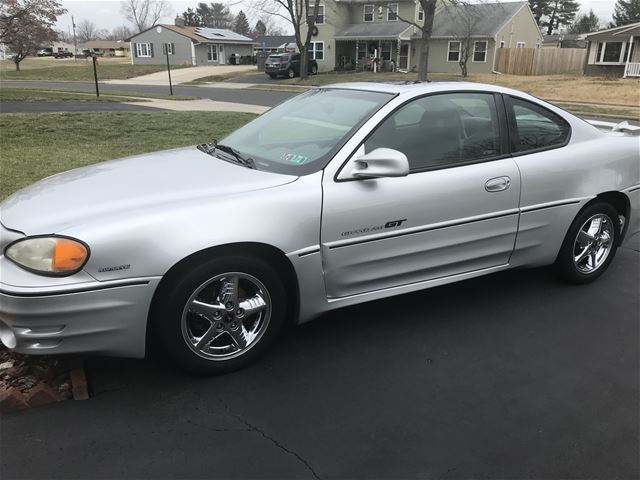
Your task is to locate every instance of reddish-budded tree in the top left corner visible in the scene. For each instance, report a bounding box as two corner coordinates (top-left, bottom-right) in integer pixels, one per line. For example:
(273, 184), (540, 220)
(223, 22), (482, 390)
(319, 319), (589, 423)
(0, 0), (66, 70)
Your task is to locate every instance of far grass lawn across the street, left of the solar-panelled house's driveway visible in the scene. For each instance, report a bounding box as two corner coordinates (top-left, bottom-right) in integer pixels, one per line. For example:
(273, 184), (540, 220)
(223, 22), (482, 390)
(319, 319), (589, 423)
(0, 57), (190, 82)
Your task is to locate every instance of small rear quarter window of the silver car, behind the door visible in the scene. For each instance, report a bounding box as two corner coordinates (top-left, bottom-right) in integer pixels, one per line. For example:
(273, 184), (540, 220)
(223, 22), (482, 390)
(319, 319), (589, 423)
(510, 97), (571, 152)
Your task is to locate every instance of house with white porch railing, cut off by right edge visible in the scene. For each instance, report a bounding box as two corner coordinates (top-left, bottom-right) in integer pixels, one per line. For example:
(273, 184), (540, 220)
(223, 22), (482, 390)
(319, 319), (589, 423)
(584, 22), (640, 78)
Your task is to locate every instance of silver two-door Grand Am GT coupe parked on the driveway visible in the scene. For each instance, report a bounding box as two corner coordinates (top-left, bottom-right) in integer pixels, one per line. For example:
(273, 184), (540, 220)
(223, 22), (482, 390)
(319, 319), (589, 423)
(0, 83), (640, 373)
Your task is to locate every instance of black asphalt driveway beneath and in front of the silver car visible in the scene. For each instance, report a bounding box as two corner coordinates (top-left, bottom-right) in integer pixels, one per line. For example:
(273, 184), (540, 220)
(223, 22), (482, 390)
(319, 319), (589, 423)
(0, 246), (640, 480)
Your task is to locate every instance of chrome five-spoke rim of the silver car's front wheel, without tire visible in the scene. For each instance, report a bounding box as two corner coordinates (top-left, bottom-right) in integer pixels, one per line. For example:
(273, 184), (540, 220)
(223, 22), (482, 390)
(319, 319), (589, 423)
(181, 272), (271, 360)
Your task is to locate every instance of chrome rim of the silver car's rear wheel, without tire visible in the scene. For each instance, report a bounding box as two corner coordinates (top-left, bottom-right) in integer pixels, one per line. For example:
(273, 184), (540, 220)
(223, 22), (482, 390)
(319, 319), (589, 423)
(573, 213), (615, 274)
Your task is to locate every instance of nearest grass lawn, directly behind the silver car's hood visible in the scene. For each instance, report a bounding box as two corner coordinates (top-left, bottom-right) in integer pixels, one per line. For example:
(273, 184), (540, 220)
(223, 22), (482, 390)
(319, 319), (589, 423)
(0, 112), (255, 199)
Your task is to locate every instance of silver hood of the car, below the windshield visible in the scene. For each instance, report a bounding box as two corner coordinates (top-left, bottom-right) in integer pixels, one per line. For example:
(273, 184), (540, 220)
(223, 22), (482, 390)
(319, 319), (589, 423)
(0, 147), (298, 235)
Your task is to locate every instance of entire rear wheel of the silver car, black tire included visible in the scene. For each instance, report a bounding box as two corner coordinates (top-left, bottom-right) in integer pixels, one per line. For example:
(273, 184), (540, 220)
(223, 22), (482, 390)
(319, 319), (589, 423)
(554, 202), (620, 284)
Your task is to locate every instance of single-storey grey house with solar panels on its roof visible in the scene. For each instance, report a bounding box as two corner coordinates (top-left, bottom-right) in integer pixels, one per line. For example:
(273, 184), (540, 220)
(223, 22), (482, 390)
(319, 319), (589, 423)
(127, 18), (256, 66)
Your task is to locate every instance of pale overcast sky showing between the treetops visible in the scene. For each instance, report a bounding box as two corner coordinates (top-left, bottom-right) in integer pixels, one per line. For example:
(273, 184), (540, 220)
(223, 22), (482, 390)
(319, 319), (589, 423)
(58, 0), (615, 32)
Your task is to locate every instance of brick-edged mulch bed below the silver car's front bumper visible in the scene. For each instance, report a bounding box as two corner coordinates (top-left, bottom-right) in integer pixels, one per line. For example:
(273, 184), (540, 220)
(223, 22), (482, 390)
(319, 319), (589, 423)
(0, 347), (73, 413)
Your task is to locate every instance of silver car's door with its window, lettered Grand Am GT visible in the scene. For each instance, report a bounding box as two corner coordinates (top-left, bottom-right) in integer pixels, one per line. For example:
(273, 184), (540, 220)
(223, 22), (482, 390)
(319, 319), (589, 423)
(321, 92), (520, 298)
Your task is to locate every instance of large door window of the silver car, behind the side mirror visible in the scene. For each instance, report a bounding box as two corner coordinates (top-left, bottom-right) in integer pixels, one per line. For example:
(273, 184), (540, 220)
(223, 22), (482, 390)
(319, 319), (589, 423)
(364, 93), (501, 171)
